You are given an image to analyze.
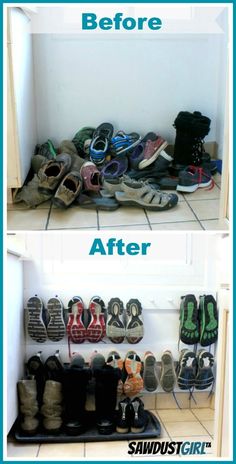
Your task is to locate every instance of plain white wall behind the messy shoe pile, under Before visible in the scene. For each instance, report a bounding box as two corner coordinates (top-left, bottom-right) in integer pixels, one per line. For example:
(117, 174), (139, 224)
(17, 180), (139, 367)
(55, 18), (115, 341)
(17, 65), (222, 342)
(33, 34), (226, 157)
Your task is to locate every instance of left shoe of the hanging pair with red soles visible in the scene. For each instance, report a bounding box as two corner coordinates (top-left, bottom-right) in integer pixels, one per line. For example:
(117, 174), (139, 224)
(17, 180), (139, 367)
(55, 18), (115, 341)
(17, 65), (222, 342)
(66, 296), (87, 343)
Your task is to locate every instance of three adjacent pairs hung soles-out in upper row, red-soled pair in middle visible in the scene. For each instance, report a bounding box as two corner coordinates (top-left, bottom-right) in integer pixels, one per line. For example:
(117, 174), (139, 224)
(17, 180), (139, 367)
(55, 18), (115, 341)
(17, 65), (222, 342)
(25, 295), (144, 344)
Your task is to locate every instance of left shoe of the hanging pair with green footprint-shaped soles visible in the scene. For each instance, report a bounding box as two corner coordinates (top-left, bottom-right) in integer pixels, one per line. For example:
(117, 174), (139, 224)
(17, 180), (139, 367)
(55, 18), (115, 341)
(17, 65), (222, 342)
(180, 295), (200, 345)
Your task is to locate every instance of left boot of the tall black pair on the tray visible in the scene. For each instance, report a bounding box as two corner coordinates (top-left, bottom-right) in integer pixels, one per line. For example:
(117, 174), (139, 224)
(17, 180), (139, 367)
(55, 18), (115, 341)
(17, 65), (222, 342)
(63, 356), (92, 435)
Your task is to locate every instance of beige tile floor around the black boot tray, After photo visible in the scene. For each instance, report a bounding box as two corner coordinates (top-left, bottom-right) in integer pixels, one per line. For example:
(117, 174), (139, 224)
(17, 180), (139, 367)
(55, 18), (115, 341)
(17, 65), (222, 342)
(7, 408), (214, 461)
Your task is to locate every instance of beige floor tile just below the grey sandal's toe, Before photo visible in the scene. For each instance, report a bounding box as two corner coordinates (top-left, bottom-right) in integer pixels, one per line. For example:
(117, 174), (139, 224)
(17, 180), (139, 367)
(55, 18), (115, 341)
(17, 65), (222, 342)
(148, 202), (196, 225)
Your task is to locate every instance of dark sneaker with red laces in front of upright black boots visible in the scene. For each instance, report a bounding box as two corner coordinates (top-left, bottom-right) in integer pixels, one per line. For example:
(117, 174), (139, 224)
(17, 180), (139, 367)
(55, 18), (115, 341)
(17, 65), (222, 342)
(177, 166), (214, 193)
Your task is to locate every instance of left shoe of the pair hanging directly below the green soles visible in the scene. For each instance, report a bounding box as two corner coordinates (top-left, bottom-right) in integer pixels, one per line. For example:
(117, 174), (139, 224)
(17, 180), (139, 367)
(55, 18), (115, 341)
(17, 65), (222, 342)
(177, 349), (197, 390)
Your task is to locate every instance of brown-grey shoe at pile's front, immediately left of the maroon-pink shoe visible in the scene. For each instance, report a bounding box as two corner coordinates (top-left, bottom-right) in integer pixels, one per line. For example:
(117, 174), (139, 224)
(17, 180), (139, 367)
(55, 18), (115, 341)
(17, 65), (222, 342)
(52, 171), (82, 208)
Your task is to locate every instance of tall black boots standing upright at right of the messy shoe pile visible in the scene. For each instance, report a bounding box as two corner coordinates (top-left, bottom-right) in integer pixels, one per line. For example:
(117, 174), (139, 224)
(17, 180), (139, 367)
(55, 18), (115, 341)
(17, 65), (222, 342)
(173, 111), (211, 170)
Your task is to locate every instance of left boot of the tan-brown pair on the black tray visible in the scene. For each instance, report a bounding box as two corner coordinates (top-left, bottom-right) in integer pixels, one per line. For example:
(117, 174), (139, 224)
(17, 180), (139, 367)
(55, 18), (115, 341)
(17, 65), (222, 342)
(17, 380), (39, 435)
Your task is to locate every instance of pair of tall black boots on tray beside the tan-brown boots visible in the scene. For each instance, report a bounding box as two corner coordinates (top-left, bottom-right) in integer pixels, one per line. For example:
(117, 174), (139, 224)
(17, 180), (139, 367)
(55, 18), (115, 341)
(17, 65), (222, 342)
(63, 357), (121, 435)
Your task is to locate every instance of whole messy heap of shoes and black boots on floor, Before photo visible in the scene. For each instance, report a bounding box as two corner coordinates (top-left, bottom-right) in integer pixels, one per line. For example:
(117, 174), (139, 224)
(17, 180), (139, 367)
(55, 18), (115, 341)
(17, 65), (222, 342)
(15, 111), (217, 211)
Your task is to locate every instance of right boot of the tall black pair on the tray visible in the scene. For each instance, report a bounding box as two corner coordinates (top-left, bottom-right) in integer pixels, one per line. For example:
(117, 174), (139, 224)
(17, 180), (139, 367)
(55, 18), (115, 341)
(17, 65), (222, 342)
(94, 365), (121, 435)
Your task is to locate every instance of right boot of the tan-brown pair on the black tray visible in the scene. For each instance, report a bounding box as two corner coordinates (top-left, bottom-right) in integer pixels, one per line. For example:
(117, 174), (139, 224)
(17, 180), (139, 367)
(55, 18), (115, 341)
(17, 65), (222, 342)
(41, 380), (62, 434)
